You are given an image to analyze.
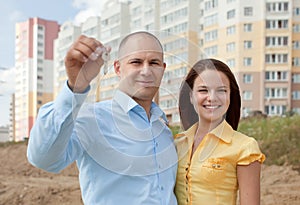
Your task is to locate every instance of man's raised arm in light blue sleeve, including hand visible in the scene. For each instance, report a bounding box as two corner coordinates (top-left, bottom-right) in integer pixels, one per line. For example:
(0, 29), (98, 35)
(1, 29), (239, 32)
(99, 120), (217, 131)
(27, 35), (109, 172)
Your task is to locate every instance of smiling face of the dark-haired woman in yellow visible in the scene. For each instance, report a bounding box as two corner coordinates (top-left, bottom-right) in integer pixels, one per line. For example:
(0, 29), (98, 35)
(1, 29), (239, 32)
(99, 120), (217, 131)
(190, 70), (230, 125)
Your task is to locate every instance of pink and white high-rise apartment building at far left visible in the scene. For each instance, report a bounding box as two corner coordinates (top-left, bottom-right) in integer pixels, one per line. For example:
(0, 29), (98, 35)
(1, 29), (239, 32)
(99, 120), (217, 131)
(14, 18), (59, 141)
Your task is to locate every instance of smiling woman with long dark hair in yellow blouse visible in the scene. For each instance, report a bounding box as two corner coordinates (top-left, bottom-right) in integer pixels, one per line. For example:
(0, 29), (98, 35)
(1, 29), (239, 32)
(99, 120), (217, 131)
(175, 59), (265, 205)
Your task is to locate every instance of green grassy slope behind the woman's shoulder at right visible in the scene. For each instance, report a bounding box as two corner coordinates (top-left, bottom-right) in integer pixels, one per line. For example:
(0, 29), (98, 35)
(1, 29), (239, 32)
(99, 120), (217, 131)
(238, 115), (300, 171)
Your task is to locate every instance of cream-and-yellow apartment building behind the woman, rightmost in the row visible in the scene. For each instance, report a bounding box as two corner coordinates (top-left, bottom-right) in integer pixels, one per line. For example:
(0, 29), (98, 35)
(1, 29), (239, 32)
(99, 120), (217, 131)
(199, 0), (299, 117)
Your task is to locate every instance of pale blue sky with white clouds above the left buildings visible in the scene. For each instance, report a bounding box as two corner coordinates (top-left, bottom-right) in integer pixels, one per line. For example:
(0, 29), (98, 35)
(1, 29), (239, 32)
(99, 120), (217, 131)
(0, 0), (107, 126)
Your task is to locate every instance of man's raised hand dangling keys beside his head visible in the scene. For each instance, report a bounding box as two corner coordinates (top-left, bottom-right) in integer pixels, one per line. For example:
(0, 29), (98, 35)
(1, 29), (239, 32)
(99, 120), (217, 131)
(65, 35), (110, 92)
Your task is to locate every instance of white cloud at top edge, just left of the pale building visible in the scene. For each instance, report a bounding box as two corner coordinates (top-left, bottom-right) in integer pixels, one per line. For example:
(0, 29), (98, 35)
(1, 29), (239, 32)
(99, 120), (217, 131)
(72, 0), (107, 25)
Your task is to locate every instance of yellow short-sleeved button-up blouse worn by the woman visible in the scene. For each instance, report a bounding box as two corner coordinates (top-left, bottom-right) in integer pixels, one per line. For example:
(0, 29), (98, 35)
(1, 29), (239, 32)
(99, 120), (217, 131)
(175, 120), (265, 205)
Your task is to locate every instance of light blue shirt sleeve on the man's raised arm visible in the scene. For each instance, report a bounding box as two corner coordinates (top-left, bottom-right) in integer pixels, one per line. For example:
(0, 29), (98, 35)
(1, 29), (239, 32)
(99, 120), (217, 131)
(27, 82), (90, 172)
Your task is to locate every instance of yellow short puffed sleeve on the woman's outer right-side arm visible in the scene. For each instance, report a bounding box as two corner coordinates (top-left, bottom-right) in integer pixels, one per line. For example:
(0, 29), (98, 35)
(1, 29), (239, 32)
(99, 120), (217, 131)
(237, 137), (265, 165)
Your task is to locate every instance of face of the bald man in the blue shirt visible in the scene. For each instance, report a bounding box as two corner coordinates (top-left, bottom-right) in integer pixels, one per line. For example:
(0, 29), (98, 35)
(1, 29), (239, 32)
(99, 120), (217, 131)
(114, 35), (166, 100)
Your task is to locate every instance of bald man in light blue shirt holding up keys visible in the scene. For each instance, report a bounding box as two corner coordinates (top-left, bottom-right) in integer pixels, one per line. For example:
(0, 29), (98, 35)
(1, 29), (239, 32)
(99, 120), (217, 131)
(27, 32), (177, 205)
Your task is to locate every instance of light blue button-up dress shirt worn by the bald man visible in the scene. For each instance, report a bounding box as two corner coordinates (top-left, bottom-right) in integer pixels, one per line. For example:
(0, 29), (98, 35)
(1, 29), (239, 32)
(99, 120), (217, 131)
(27, 82), (177, 205)
